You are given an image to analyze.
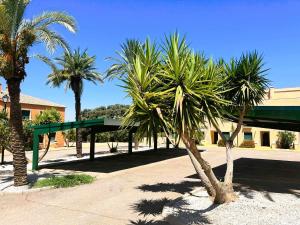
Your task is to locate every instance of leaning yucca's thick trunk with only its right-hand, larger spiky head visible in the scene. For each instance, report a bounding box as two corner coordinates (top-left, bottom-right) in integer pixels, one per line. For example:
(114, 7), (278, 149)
(158, 34), (230, 203)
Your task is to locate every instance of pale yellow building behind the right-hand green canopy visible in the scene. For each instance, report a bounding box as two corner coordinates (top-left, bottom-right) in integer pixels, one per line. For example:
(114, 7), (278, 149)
(203, 87), (300, 149)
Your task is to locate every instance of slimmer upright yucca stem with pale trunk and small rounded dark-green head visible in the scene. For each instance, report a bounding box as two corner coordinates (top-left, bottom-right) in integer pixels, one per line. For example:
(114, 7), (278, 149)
(212, 51), (269, 196)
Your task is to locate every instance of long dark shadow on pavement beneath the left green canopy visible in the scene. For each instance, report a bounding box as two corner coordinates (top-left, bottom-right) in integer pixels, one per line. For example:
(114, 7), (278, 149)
(40, 149), (187, 173)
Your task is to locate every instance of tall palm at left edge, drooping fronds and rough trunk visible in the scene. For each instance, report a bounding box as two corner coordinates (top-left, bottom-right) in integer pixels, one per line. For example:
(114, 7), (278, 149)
(0, 0), (76, 186)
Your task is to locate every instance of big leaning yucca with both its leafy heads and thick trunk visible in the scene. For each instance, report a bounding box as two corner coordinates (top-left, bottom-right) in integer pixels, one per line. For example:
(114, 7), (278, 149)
(108, 34), (236, 202)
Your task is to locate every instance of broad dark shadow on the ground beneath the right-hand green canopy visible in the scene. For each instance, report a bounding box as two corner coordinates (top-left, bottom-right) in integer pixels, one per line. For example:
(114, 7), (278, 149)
(189, 158), (300, 198)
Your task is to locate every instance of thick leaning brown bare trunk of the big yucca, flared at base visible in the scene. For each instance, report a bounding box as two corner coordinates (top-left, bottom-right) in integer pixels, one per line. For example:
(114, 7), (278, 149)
(181, 132), (236, 204)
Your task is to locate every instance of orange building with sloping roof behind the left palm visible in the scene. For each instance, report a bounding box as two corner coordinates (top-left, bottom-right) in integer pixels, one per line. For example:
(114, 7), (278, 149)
(0, 84), (66, 147)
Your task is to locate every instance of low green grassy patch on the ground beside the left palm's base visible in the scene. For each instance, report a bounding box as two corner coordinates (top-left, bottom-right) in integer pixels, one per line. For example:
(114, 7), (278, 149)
(33, 174), (95, 188)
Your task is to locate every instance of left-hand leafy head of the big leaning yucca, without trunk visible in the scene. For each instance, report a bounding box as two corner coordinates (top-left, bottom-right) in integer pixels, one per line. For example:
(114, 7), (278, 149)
(106, 39), (160, 142)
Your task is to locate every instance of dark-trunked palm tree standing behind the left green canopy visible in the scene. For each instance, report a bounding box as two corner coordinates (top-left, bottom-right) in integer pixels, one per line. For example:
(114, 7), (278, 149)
(44, 49), (102, 158)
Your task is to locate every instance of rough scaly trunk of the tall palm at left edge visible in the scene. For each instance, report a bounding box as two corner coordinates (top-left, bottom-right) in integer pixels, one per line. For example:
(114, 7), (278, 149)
(7, 78), (28, 186)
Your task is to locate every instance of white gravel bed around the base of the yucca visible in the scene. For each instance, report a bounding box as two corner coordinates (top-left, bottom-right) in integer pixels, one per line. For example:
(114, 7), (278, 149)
(163, 189), (300, 225)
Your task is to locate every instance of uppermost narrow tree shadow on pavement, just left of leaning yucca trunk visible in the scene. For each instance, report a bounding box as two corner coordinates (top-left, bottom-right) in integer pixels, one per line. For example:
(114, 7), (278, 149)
(137, 181), (201, 194)
